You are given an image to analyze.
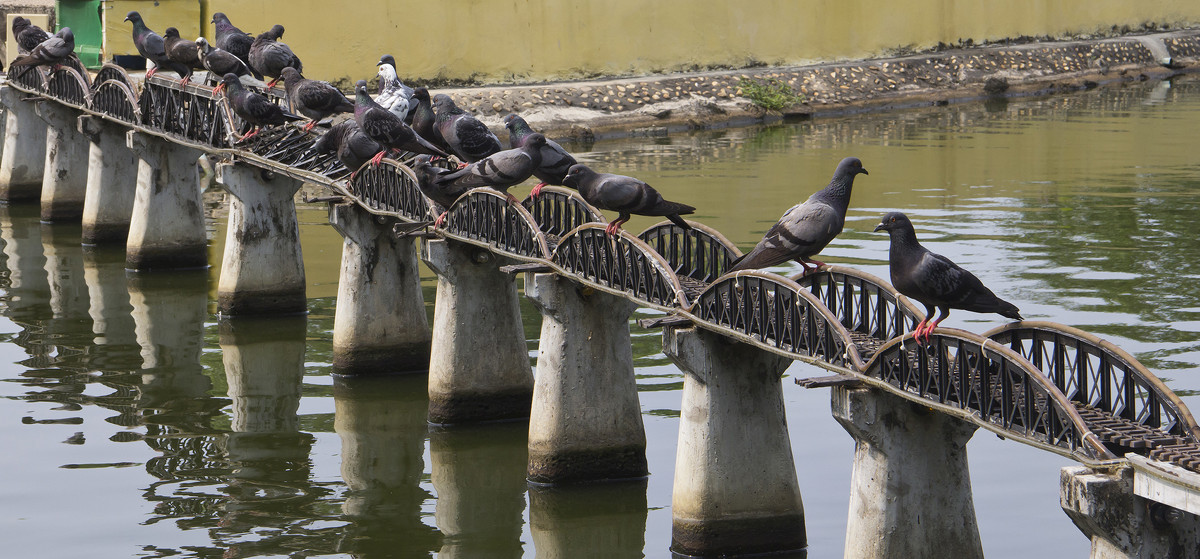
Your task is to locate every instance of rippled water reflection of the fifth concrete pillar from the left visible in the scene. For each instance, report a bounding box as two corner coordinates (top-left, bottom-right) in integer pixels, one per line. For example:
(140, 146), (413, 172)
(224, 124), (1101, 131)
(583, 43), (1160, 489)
(220, 315), (319, 537)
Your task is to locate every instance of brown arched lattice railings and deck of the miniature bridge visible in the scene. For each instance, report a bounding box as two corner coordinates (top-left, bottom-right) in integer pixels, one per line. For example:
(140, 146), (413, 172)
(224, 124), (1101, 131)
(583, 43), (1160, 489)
(5, 66), (1200, 549)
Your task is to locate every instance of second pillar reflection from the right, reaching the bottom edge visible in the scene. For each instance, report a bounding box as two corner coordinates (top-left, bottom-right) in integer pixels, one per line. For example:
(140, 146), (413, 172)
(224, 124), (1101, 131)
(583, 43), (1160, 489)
(430, 421), (529, 559)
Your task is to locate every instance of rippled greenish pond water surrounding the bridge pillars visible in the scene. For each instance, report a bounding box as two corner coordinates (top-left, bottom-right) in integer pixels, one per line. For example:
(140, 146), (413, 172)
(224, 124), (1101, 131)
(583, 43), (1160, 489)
(0, 78), (1200, 558)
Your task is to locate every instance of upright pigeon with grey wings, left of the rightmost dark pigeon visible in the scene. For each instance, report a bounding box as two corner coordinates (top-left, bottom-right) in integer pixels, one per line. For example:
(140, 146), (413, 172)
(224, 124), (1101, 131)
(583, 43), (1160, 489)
(728, 157), (869, 274)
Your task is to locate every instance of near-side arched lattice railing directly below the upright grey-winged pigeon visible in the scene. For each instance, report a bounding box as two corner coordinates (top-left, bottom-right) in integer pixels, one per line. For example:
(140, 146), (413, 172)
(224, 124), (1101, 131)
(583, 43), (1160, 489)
(691, 270), (862, 368)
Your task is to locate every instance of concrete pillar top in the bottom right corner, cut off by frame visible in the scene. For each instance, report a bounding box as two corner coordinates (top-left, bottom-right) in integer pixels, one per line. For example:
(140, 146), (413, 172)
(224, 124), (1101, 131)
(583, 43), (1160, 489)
(1058, 465), (1200, 559)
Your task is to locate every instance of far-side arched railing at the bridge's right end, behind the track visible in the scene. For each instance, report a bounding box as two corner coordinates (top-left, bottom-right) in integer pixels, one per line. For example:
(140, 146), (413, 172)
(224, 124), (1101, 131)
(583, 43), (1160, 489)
(983, 320), (1200, 443)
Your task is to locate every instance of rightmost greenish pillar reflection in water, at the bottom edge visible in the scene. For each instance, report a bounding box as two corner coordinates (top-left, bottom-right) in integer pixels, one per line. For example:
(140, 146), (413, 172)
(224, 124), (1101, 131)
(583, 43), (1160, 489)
(529, 481), (648, 559)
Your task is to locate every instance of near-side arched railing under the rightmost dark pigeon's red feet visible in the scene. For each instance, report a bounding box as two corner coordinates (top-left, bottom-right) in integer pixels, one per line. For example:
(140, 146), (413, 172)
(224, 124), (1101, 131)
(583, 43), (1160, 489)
(860, 329), (1115, 461)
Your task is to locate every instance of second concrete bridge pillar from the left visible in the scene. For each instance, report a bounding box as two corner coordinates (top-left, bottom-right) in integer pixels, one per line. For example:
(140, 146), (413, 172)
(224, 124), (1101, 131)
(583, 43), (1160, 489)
(37, 102), (89, 222)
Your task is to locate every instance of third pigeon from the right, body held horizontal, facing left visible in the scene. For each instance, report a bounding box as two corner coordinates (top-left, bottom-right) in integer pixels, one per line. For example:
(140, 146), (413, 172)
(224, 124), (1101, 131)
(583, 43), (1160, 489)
(564, 163), (696, 235)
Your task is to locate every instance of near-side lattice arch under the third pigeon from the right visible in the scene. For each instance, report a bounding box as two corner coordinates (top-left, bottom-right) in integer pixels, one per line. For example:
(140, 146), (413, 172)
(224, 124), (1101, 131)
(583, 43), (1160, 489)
(552, 223), (688, 308)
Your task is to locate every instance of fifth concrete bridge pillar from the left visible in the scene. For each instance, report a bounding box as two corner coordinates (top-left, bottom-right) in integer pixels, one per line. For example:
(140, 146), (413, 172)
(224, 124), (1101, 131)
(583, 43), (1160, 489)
(217, 163), (307, 315)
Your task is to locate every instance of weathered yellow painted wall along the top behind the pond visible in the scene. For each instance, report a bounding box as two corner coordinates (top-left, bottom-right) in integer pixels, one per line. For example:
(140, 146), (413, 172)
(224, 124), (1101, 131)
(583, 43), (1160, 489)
(100, 0), (1200, 83)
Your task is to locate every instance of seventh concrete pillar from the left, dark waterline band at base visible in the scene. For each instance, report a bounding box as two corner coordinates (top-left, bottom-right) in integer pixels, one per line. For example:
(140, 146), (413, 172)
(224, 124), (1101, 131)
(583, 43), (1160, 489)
(422, 240), (533, 423)
